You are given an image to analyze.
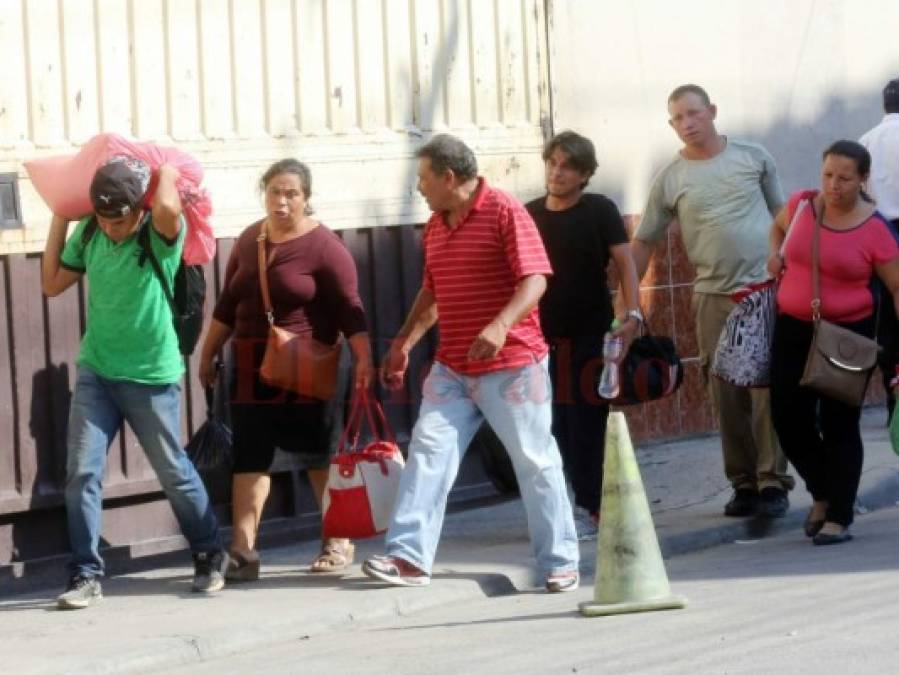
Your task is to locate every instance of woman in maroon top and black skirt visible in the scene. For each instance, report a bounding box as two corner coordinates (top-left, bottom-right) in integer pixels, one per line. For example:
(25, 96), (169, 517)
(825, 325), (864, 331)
(200, 159), (373, 581)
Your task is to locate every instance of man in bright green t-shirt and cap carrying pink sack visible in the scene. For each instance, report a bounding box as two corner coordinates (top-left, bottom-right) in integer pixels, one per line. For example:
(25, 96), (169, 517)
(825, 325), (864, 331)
(42, 157), (227, 609)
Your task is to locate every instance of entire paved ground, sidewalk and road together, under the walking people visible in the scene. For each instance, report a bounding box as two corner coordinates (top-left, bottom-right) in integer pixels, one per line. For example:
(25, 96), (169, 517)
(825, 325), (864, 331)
(0, 409), (899, 675)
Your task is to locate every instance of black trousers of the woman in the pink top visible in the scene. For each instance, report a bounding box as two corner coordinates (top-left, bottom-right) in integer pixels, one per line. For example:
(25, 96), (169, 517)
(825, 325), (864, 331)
(771, 314), (874, 526)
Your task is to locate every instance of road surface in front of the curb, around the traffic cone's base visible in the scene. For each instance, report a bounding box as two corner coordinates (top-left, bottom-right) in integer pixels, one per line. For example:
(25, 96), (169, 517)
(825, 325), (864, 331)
(167, 508), (899, 675)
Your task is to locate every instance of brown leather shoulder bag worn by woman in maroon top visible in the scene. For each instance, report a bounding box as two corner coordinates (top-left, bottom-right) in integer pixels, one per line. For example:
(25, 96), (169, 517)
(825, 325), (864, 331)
(256, 222), (341, 401)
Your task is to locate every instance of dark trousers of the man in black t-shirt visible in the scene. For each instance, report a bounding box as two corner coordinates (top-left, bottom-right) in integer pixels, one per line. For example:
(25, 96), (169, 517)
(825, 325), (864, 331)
(549, 336), (609, 513)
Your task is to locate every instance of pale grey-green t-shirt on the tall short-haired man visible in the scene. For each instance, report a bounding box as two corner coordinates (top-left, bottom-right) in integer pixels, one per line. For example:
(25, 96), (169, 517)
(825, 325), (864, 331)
(634, 139), (784, 294)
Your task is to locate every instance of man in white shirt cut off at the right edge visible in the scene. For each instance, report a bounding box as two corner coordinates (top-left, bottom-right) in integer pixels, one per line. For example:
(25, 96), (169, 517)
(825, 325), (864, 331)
(859, 79), (899, 417)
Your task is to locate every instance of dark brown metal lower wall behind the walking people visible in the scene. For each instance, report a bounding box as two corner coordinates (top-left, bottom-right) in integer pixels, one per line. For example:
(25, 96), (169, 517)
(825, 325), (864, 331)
(0, 225), (486, 578)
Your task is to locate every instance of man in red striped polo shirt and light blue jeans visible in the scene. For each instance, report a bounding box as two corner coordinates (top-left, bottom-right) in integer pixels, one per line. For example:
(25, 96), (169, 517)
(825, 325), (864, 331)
(362, 134), (579, 592)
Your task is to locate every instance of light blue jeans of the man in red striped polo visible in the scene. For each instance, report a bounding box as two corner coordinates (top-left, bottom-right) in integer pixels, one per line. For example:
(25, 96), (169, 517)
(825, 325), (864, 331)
(387, 358), (579, 576)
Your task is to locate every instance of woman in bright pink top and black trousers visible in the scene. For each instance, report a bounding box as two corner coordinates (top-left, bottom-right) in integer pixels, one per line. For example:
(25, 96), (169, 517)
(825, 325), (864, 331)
(768, 141), (899, 545)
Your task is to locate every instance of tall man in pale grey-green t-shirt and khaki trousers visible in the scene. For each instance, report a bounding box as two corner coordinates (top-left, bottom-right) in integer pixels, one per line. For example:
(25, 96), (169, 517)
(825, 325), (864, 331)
(631, 84), (793, 517)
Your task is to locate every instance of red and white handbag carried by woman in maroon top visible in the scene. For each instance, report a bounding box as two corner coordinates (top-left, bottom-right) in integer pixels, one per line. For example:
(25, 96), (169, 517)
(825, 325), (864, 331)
(322, 390), (404, 539)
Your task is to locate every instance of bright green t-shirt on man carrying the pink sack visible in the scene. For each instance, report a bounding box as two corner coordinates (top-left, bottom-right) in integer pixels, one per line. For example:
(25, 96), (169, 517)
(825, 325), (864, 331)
(60, 215), (186, 384)
